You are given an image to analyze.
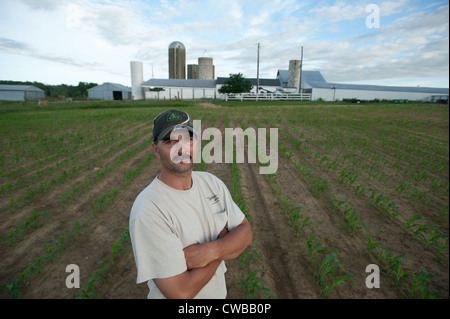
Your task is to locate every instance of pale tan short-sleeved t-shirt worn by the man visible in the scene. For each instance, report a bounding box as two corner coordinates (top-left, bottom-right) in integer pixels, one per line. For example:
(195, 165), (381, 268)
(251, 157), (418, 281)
(130, 171), (245, 299)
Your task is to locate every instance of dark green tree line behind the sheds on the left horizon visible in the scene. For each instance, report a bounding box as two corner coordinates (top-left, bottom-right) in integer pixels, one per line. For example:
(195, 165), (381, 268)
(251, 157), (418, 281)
(0, 80), (98, 98)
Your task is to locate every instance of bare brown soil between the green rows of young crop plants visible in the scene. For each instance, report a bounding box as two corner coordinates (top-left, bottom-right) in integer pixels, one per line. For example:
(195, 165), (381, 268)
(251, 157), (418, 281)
(0, 103), (449, 299)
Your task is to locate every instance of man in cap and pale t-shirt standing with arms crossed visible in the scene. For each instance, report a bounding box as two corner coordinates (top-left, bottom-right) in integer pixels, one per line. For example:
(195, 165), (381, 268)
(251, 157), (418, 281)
(130, 109), (252, 299)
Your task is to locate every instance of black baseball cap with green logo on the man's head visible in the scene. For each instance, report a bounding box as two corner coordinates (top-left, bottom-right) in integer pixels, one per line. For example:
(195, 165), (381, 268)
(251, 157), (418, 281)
(153, 109), (195, 142)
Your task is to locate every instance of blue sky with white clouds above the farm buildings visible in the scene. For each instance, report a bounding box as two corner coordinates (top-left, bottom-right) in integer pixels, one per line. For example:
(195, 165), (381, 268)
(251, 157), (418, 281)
(0, 0), (449, 88)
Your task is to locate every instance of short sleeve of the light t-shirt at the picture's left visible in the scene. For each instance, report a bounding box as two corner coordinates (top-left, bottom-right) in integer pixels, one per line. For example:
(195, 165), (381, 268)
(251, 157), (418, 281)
(130, 203), (187, 283)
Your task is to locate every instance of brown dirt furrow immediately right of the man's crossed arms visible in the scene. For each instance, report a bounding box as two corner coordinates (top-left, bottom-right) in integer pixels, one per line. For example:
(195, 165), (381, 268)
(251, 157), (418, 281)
(242, 164), (318, 298)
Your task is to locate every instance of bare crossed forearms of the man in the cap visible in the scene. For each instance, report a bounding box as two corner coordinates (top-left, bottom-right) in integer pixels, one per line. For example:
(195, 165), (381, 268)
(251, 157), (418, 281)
(153, 218), (252, 299)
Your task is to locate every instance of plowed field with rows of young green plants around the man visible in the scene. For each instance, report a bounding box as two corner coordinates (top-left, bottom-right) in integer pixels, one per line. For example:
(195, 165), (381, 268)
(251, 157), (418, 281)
(0, 102), (449, 298)
